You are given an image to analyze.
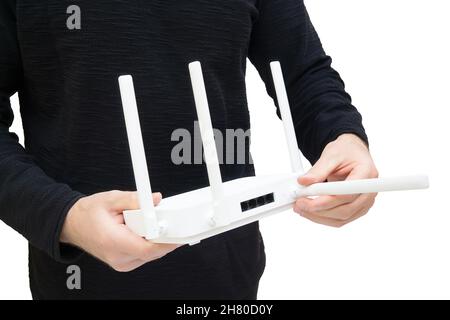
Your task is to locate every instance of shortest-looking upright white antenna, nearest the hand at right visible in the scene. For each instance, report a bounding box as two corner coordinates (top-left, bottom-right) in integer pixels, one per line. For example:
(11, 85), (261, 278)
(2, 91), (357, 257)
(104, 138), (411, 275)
(270, 61), (304, 173)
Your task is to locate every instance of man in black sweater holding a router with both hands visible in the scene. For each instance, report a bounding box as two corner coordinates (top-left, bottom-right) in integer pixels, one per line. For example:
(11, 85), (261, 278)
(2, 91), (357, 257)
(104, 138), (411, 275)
(0, 0), (377, 299)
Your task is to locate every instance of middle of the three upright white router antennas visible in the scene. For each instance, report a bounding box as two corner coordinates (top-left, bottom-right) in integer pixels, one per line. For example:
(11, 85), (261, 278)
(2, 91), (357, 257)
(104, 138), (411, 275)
(189, 61), (223, 208)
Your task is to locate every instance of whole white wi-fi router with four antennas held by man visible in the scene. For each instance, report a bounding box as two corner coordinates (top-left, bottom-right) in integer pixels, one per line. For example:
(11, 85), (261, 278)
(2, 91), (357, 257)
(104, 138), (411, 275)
(119, 61), (428, 245)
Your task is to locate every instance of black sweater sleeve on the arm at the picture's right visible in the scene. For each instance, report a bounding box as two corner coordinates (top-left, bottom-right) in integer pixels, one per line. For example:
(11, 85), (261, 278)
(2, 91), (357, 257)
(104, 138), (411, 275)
(248, 0), (367, 163)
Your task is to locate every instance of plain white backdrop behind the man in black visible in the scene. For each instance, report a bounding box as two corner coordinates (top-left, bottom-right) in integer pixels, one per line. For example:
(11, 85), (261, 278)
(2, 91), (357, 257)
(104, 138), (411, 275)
(0, 0), (450, 299)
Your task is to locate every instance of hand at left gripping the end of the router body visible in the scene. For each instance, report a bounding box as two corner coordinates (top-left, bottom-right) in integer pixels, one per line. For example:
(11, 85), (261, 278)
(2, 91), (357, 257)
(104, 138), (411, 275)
(60, 191), (179, 272)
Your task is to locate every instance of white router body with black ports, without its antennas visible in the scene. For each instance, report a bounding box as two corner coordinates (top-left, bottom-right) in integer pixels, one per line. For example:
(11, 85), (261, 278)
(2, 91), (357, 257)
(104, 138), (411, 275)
(125, 174), (298, 244)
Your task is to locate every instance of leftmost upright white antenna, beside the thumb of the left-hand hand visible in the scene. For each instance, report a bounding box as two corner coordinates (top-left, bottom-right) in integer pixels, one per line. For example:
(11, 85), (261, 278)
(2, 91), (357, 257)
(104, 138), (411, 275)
(119, 75), (159, 239)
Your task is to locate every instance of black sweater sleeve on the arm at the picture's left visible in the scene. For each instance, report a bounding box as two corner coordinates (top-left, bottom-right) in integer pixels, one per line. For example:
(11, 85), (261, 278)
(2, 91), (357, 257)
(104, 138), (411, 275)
(0, 0), (82, 261)
